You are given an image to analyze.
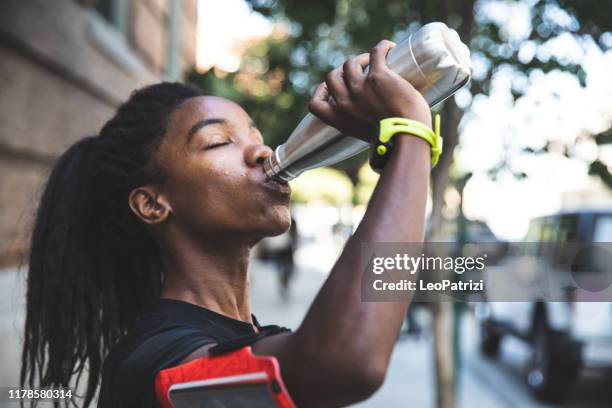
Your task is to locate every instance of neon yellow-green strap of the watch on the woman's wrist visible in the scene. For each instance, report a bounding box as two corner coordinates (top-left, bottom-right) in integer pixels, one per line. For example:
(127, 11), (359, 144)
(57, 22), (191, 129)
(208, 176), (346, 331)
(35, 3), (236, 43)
(376, 115), (442, 167)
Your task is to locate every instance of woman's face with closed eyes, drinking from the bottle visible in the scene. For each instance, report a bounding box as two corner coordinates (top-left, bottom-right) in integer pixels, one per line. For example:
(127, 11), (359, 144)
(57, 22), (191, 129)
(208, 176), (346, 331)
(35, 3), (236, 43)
(157, 96), (291, 239)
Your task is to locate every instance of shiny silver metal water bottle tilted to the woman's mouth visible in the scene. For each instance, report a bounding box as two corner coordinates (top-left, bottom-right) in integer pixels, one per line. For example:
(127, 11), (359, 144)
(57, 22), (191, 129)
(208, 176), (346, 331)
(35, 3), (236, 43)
(264, 22), (472, 181)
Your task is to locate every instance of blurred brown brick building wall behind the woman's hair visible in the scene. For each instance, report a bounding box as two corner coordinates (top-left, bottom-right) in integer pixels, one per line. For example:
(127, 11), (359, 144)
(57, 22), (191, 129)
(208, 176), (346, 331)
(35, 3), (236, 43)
(0, 0), (196, 267)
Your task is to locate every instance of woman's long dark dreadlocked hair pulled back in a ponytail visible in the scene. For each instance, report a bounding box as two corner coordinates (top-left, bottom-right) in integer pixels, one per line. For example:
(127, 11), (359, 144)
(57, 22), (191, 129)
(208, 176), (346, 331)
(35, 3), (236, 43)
(20, 83), (202, 408)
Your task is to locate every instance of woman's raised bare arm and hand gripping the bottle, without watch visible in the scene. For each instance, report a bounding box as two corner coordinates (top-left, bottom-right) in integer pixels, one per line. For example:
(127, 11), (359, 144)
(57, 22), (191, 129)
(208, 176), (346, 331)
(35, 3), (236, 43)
(253, 41), (431, 407)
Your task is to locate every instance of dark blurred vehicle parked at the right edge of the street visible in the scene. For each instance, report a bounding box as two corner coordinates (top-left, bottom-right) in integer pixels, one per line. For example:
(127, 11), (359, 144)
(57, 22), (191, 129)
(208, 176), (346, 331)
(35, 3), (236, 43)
(476, 209), (612, 402)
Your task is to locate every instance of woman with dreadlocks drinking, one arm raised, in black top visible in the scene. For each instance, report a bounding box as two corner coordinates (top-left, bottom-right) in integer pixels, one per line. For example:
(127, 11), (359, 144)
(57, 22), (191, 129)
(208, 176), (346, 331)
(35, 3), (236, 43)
(21, 41), (431, 408)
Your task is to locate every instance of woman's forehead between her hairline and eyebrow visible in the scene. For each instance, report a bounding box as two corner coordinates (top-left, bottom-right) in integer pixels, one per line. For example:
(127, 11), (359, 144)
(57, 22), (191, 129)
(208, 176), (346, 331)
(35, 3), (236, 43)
(169, 96), (250, 133)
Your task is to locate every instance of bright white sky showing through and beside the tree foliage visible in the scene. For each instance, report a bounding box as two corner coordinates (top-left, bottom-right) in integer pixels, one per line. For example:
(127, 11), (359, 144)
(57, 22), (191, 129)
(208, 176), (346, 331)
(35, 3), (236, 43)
(198, 0), (612, 240)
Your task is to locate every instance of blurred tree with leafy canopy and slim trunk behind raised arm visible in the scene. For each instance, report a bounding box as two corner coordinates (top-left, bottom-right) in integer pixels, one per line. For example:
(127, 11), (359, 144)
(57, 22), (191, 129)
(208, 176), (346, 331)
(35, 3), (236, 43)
(190, 0), (612, 407)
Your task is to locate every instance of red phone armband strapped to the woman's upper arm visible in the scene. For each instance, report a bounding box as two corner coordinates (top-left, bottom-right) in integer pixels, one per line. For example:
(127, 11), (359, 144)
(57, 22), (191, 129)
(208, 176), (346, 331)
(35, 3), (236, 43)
(155, 346), (295, 408)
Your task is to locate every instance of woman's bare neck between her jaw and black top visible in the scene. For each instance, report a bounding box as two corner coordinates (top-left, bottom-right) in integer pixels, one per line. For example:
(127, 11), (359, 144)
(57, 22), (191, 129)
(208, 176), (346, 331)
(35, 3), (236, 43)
(161, 231), (252, 323)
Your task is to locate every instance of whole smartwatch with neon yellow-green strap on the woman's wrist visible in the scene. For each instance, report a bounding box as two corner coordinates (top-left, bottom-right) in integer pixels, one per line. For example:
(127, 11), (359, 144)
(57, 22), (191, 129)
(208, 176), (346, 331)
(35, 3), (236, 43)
(370, 115), (442, 173)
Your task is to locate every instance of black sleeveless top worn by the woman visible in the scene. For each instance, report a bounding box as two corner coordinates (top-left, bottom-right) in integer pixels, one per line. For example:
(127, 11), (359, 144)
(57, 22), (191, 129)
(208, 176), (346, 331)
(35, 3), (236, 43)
(98, 299), (287, 408)
